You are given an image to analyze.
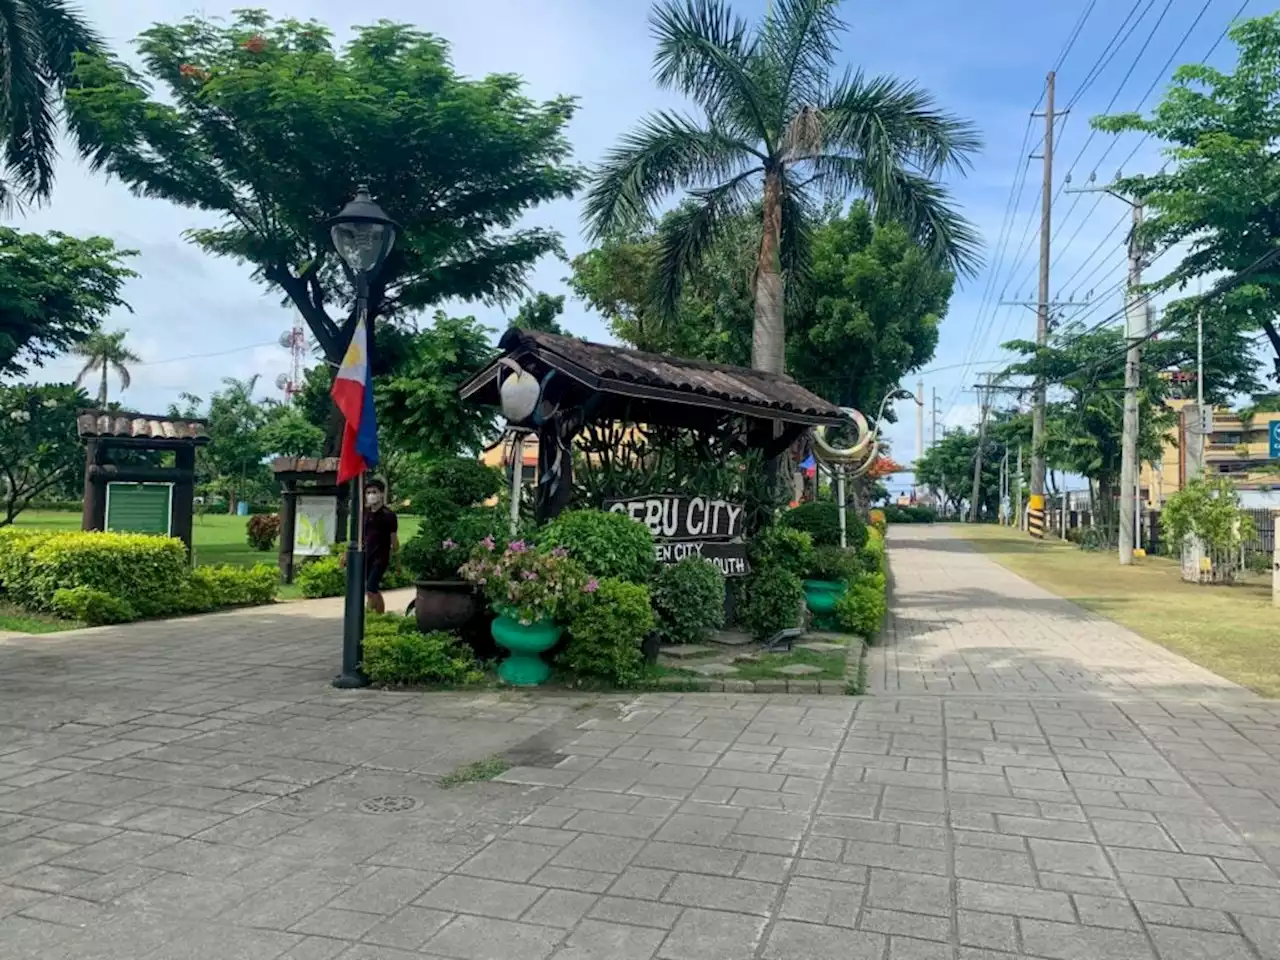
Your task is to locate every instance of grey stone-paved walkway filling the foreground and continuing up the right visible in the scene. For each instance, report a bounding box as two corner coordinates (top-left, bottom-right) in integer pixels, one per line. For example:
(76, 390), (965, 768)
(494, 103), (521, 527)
(0, 547), (1280, 960)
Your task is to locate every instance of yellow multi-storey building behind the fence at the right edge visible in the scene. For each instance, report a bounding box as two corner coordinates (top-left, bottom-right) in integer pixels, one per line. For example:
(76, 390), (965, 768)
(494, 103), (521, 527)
(1139, 399), (1280, 507)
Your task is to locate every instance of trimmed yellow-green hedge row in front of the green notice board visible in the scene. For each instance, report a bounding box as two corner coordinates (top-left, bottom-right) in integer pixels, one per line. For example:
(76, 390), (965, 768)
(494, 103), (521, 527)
(0, 529), (279, 625)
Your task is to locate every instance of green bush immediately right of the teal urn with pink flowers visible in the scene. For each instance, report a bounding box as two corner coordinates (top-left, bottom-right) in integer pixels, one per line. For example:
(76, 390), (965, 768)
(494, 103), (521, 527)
(561, 578), (655, 687)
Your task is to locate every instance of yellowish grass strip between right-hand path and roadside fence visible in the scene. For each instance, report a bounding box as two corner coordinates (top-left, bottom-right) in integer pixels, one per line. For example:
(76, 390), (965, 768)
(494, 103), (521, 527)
(951, 525), (1280, 696)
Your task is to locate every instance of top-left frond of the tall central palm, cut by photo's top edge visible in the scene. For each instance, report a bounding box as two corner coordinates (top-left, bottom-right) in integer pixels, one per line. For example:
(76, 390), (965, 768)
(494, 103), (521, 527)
(649, 0), (776, 146)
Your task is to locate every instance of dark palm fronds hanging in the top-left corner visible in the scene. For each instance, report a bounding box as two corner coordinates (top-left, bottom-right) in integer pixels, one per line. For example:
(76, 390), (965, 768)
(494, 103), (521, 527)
(0, 0), (102, 209)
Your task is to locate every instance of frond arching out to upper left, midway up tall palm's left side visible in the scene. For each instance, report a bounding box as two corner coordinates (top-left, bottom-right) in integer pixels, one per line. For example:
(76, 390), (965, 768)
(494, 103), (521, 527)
(582, 113), (754, 239)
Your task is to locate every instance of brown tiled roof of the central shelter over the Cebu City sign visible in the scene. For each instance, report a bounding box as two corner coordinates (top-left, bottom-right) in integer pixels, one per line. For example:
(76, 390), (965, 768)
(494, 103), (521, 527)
(460, 328), (847, 425)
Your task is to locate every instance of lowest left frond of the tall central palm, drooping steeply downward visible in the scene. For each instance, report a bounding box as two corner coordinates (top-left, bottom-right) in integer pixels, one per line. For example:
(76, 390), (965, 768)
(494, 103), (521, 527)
(654, 170), (756, 317)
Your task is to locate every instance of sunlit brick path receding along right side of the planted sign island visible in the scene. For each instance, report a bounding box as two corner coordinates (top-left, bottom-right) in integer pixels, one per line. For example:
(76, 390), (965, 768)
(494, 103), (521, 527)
(868, 526), (1252, 699)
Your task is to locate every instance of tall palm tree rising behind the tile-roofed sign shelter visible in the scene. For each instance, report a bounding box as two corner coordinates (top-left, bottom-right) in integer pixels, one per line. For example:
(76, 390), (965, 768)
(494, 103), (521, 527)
(585, 0), (980, 372)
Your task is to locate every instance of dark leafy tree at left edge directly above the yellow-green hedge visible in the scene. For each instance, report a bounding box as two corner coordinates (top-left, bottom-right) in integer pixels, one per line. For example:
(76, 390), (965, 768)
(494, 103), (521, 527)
(0, 384), (87, 526)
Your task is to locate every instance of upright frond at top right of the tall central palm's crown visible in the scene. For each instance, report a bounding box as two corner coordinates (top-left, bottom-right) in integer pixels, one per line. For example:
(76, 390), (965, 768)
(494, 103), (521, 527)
(763, 0), (845, 120)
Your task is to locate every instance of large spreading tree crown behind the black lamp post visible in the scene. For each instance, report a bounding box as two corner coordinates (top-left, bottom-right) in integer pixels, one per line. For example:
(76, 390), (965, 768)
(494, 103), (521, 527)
(69, 10), (582, 361)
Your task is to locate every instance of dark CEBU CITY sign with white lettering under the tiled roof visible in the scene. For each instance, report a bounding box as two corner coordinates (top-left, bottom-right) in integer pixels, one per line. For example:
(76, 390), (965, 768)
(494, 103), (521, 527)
(603, 494), (751, 577)
